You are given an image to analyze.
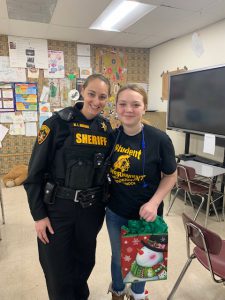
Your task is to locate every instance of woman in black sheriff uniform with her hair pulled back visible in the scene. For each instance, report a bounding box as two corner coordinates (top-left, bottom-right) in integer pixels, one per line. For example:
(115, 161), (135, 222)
(24, 74), (111, 300)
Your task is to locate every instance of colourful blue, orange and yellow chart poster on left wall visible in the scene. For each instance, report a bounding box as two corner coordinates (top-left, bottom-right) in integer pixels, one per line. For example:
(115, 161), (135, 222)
(15, 83), (38, 111)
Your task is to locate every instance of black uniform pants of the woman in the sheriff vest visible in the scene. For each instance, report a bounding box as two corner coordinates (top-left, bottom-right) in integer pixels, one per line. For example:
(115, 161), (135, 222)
(38, 198), (105, 300)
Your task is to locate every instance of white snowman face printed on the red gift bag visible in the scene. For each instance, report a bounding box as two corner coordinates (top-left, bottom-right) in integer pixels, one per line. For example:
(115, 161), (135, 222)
(136, 247), (163, 267)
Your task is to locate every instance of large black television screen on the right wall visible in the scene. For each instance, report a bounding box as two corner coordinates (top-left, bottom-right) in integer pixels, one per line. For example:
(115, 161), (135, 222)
(167, 66), (225, 138)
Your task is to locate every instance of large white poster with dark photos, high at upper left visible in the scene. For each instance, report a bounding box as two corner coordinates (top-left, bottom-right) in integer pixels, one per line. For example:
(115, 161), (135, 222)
(8, 36), (48, 69)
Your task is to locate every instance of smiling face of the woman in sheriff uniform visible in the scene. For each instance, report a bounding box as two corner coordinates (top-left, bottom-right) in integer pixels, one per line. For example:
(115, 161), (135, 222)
(82, 78), (109, 119)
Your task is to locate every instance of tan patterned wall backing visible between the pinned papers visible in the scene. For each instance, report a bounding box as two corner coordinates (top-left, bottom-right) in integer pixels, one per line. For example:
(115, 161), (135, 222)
(0, 35), (153, 174)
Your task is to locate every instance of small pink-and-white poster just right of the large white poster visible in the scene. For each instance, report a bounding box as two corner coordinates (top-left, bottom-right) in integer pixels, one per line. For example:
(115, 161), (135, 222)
(44, 50), (65, 78)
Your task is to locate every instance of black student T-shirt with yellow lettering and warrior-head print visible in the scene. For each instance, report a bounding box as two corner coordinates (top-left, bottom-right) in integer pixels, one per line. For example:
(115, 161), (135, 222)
(108, 125), (176, 219)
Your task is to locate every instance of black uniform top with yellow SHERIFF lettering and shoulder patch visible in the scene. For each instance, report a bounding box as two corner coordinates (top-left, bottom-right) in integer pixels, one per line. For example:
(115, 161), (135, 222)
(24, 107), (111, 220)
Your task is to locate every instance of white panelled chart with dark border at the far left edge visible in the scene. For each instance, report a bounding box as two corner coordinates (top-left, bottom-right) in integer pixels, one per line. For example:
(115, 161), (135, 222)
(0, 82), (15, 112)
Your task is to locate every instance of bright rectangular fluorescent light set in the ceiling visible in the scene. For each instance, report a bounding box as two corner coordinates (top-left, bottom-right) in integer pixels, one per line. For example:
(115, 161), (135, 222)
(90, 0), (156, 31)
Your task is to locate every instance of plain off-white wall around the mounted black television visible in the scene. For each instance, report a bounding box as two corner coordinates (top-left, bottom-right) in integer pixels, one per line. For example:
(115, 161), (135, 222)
(149, 20), (225, 162)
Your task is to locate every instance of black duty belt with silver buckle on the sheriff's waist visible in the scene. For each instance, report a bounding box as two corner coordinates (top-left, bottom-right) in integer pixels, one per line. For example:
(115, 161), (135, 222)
(55, 186), (103, 208)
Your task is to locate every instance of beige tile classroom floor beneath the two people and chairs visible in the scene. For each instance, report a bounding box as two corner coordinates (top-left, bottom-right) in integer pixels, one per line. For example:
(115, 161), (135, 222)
(0, 186), (225, 300)
